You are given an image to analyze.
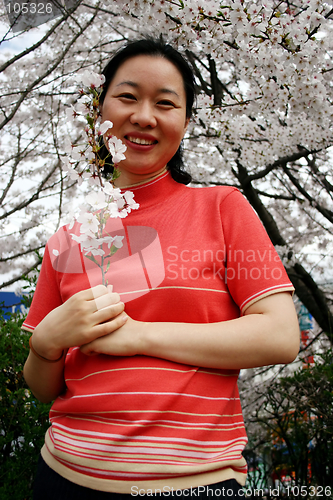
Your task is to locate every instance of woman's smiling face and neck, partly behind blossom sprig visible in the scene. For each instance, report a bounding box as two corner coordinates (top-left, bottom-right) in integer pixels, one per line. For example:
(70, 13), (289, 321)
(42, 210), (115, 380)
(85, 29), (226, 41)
(101, 55), (189, 187)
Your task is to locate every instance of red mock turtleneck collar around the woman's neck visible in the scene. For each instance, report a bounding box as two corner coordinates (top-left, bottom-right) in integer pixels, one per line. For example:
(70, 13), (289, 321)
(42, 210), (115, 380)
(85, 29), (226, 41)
(121, 171), (185, 210)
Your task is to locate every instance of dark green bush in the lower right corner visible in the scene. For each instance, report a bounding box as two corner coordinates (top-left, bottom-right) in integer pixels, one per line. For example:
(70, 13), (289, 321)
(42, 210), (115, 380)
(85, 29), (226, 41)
(261, 351), (333, 487)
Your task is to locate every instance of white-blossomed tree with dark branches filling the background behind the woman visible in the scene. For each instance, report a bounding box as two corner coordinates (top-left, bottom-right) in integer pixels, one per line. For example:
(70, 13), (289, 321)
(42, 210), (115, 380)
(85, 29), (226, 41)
(0, 0), (333, 339)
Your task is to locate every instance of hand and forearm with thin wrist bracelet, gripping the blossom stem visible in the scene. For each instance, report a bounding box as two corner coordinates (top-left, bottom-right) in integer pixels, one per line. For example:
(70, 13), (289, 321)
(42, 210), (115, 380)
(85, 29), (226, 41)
(24, 285), (124, 402)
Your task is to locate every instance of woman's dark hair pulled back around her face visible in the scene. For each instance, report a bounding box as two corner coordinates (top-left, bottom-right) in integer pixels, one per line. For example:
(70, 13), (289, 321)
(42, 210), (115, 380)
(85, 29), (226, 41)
(100, 37), (195, 184)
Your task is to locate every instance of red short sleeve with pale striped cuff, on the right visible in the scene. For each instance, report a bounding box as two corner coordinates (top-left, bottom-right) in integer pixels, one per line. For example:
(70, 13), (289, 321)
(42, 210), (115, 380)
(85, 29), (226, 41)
(221, 189), (294, 313)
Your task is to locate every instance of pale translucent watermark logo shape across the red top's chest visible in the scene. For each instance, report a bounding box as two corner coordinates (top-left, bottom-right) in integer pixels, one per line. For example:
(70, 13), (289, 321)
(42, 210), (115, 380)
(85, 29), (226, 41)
(48, 219), (165, 303)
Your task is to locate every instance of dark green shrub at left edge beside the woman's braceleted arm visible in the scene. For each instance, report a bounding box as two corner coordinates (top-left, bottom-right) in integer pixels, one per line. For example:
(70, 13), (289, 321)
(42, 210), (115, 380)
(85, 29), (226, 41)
(0, 314), (50, 500)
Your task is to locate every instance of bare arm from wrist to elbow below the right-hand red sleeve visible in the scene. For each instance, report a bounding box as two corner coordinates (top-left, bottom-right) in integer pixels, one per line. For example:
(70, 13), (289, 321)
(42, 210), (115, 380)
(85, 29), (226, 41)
(140, 294), (299, 369)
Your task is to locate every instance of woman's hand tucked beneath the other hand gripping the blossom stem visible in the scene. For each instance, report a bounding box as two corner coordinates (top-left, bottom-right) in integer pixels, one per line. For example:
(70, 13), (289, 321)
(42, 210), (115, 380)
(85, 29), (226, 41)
(80, 316), (144, 356)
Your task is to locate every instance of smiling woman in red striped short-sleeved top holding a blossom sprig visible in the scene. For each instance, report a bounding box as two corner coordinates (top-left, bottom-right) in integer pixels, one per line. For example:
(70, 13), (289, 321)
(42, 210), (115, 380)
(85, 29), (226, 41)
(24, 40), (299, 499)
